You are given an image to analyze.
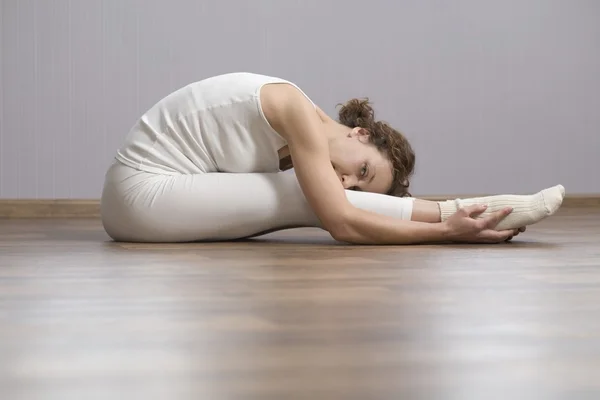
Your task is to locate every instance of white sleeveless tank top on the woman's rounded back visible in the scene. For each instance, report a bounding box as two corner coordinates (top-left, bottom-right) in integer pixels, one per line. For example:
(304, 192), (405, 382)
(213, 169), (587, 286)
(116, 73), (314, 174)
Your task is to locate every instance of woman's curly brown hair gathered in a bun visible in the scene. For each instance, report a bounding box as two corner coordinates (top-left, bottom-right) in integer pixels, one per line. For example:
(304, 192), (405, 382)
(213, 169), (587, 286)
(338, 98), (415, 197)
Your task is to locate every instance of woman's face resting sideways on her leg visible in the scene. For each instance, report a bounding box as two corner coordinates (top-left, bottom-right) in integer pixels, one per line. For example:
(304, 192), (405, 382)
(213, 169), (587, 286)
(329, 128), (393, 193)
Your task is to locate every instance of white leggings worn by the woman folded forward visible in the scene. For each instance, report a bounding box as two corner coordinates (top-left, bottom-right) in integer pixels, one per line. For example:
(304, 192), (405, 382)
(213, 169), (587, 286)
(101, 162), (414, 243)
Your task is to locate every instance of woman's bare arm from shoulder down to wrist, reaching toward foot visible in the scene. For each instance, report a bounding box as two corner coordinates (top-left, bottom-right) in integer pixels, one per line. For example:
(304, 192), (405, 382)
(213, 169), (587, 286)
(261, 84), (508, 244)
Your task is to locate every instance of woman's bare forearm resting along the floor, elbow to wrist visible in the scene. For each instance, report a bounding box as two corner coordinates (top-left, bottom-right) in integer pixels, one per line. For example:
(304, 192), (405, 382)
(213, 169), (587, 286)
(330, 208), (449, 245)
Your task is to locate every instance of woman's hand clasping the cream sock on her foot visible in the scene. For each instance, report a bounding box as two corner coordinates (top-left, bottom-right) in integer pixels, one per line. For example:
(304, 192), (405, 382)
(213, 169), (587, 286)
(443, 205), (525, 243)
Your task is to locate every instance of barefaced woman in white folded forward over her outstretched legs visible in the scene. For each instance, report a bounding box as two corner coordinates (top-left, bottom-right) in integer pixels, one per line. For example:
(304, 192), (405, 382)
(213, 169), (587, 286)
(101, 73), (564, 244)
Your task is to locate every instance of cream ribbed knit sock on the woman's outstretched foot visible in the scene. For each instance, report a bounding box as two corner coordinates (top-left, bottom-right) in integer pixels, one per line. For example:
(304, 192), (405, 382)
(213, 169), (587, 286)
(438, 185), (565, 230)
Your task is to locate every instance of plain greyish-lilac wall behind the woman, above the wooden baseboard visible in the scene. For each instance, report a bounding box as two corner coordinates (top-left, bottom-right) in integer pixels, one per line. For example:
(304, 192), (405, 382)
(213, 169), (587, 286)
(0, 0), (600, 198)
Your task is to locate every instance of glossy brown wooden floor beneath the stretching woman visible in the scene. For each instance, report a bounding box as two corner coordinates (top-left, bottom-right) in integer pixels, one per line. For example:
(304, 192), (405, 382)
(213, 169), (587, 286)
(0, 209), (600, 400)
